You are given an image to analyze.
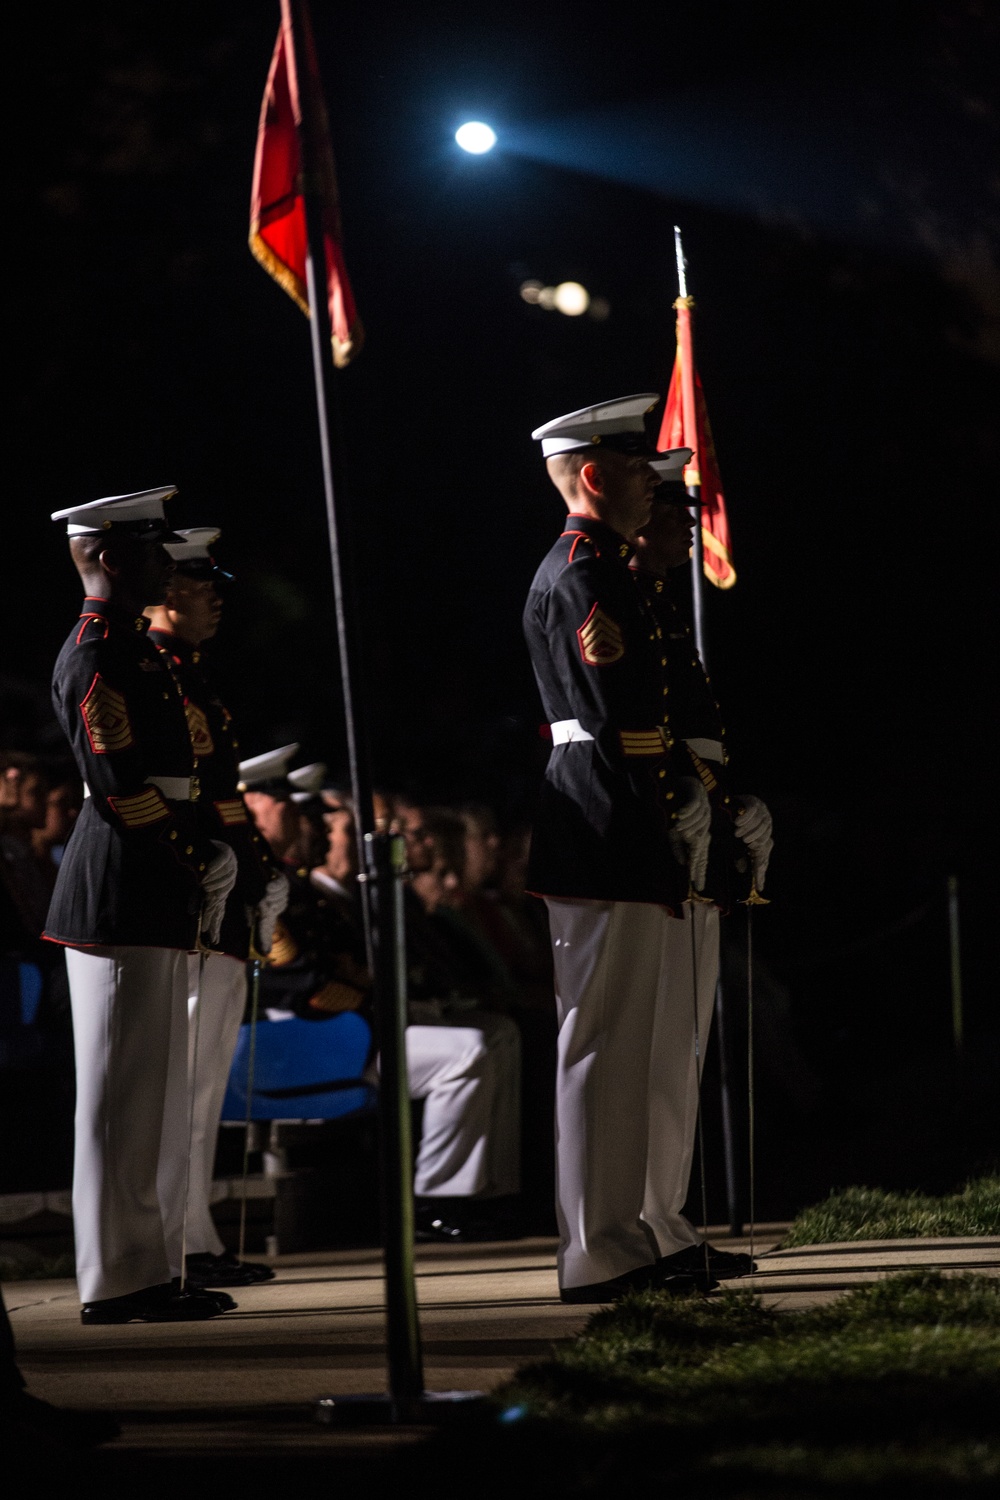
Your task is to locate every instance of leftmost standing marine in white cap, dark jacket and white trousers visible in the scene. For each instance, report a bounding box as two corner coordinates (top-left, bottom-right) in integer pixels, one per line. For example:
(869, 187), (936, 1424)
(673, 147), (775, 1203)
(45, 488), (235, 1323)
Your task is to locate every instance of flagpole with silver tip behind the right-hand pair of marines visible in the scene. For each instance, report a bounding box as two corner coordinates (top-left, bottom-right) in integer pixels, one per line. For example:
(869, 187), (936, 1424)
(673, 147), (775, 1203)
(673, 224), (744, 1238)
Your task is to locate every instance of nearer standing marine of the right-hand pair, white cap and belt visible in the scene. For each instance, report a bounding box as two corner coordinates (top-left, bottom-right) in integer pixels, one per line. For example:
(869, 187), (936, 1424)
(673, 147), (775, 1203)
(523, 395), (718, 1302)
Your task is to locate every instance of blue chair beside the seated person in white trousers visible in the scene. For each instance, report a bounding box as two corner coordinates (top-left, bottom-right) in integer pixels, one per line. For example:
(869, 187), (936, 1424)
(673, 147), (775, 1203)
(222, 1011), (376, 1122)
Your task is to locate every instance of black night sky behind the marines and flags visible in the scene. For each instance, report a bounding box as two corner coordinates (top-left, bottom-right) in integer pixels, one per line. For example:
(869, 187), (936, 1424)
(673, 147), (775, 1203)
(1, 0), (1000, 1194)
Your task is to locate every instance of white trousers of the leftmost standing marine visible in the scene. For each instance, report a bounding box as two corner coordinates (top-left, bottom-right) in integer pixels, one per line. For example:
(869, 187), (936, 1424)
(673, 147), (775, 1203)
(66, 947), (187, 1302)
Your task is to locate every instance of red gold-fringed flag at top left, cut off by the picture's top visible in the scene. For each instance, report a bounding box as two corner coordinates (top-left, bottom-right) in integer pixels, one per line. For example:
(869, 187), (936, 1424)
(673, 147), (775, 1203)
(250, 0), (364, 366)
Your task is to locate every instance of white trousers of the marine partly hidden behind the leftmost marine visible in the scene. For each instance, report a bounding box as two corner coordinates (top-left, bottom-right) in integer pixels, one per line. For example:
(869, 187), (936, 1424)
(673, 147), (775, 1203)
(156, 953), (246, 1277)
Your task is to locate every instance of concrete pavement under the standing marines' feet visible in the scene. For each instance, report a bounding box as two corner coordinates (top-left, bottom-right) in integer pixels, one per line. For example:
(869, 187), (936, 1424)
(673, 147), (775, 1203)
(4, 1226), (1000, 1461)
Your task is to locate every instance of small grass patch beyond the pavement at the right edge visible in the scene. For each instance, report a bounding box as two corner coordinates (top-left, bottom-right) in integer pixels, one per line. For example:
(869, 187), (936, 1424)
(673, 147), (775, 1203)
(781, 1176), (1000, 1250)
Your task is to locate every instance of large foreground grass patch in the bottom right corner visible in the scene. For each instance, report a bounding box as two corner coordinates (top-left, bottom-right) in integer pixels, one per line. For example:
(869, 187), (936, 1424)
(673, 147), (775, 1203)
(434, 1271), (1000, 1500)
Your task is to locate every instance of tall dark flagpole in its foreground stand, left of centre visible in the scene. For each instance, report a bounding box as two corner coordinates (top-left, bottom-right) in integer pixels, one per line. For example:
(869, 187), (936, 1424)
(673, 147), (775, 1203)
(282, 0), (424, 1421)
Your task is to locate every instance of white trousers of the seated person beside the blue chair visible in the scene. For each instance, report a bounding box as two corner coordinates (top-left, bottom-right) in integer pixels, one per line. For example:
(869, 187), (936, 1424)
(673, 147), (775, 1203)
(406, 1002), (520, 1199)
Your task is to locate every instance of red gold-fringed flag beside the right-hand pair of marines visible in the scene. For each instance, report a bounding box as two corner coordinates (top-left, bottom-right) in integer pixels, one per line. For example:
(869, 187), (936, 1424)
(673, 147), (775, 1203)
(657, 297), (736, 588)
